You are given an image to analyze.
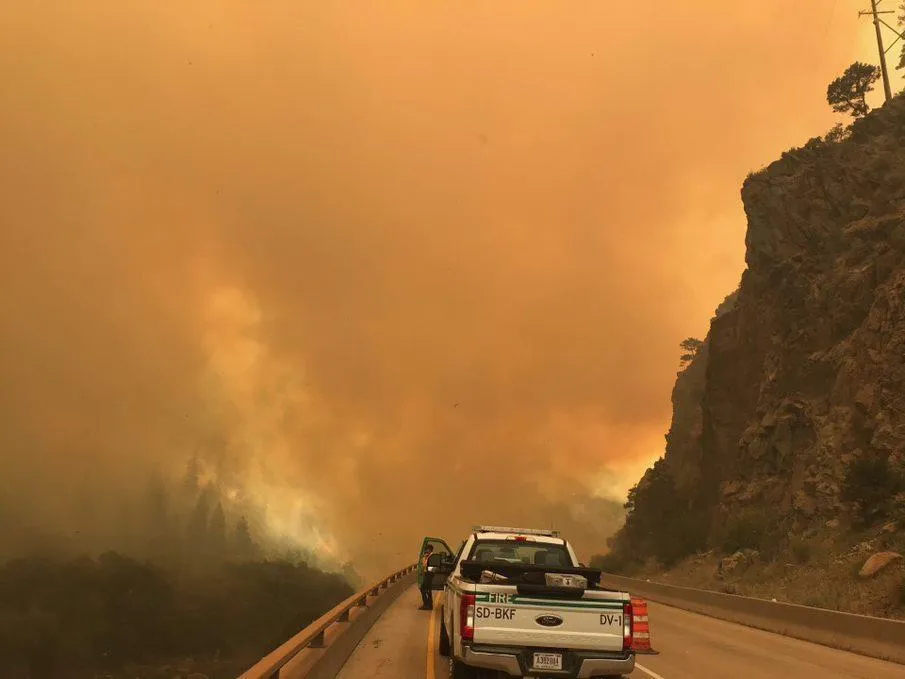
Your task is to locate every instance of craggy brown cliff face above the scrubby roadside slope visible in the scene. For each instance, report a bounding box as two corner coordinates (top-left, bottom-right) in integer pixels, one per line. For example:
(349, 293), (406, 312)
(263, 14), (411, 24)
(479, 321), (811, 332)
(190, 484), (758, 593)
(614, 96), (905, 564)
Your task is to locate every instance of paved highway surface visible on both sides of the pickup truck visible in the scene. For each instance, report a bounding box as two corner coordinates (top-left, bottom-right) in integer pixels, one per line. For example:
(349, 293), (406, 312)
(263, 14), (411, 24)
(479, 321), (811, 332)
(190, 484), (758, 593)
(338, 586), (905, 679)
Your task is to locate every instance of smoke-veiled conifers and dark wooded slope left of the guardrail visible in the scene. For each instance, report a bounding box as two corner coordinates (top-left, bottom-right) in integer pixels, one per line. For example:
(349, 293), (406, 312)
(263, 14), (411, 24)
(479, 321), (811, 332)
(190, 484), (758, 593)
(0, 458), (360, 679)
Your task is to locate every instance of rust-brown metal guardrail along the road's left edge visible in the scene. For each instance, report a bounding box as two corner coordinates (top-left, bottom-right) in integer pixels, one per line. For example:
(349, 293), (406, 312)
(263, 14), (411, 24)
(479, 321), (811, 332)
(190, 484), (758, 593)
(239, 564), (417, 679)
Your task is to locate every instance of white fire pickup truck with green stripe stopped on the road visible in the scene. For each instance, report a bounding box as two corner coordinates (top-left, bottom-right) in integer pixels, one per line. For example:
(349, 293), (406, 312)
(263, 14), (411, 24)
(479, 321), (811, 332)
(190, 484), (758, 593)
(428, 526), (635, 679)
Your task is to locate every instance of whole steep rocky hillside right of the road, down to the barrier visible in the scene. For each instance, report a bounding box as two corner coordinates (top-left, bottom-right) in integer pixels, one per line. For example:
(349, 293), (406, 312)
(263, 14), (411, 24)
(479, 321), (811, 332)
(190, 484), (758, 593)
(606, 96), (905, 614)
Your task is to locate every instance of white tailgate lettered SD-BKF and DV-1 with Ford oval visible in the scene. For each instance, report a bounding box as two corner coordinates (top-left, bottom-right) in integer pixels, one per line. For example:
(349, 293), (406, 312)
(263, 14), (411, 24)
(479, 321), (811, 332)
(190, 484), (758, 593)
(474, 587), (624, 652)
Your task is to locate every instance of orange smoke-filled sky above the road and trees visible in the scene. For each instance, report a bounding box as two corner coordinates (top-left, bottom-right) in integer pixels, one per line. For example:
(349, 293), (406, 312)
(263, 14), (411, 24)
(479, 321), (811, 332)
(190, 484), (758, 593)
(0, 0), (901, 567)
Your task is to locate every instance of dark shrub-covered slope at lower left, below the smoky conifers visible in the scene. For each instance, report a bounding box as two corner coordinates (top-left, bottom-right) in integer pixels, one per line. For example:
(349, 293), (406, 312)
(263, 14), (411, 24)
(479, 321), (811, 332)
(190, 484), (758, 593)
(0, 552), (353, 679)
